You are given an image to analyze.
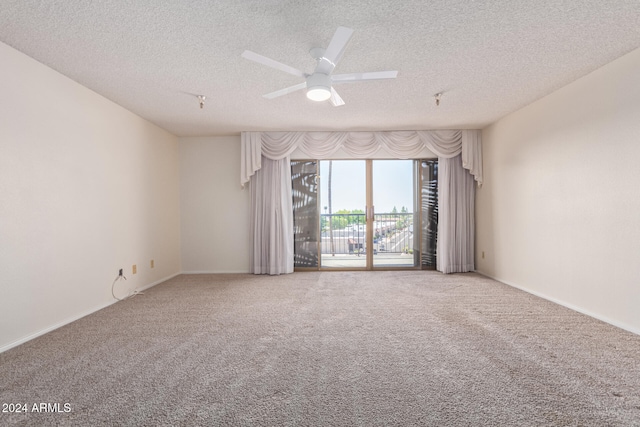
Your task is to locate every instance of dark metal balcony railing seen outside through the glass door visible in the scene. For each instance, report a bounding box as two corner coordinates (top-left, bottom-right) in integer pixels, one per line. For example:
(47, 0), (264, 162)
(321, 213), (414, 255)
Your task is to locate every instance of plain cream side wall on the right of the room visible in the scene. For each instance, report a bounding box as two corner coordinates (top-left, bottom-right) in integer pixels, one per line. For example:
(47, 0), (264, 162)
(476, 49), (640, 333)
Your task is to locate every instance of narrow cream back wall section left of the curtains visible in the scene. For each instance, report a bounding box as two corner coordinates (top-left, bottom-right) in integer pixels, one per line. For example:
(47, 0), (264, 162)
(180, 136), (251, 273)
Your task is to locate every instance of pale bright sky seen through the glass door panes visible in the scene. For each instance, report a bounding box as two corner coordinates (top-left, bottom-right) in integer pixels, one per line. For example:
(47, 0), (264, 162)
(320, 160), (413, 214)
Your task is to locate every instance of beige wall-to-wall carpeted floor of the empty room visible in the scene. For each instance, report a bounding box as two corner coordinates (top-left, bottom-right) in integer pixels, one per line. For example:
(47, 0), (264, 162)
(0, 271), (640, 426)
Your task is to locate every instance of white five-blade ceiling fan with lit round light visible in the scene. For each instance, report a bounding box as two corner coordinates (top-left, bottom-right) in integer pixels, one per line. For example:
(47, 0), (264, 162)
(242, 27), (398, 107)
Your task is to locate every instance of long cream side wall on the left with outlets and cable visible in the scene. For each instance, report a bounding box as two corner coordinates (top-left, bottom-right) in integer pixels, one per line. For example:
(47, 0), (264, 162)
(0, 43), (180, 351)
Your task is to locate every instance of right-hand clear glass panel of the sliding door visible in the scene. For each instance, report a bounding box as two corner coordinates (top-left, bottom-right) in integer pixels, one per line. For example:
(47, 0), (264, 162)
(371, 160), (420, 268)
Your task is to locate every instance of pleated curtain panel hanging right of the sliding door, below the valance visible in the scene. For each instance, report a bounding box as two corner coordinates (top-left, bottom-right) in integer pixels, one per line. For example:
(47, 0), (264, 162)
(436, 155), (475, 273)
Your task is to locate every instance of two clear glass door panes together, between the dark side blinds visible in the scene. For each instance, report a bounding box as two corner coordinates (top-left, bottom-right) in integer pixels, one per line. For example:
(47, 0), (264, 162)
(320, 160), (420, 269)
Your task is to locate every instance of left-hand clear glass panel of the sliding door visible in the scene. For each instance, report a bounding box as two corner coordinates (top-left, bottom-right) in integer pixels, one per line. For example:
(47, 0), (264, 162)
(320, 160), (367, 269)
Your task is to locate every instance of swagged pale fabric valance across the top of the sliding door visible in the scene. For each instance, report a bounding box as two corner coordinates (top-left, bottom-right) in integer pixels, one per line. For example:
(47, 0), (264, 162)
(240, 130), (482, 187)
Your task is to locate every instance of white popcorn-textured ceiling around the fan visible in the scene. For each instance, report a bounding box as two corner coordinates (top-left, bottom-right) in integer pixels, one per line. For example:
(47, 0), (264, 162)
(0, 0), (640, 136)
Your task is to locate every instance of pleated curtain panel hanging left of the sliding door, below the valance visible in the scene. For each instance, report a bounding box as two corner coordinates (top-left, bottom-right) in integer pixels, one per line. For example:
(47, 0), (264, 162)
(250, 157), (293, 275)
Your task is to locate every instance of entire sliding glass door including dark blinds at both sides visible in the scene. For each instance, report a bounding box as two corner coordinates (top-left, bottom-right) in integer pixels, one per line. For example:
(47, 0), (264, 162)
(291, 160), (437, 270)
